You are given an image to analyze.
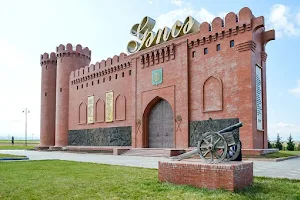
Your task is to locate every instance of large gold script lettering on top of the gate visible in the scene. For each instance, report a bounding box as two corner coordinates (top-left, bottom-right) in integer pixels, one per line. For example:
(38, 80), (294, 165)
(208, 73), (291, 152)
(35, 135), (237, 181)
(127, 16), (200, 53)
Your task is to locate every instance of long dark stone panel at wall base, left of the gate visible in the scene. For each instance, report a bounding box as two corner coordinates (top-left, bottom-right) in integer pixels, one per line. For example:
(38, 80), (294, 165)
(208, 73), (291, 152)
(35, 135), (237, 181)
(68, 126), (131, 146)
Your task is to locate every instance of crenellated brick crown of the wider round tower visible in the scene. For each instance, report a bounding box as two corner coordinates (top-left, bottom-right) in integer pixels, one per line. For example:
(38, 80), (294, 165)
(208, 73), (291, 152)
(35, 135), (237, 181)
(56, 43), (91, 59)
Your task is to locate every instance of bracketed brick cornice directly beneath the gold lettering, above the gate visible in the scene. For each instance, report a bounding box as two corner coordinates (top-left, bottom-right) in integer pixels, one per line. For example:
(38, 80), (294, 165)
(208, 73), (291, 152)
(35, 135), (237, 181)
(140, 43), (175, 69)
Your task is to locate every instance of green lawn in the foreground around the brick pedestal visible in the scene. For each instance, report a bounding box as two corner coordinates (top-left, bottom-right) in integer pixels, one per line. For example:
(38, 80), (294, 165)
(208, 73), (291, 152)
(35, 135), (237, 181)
(0, 161), (300, 200)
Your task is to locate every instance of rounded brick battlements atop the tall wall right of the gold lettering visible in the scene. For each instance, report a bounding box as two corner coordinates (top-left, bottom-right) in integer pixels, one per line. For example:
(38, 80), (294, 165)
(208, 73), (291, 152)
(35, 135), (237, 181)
(188, 7), (264, 48)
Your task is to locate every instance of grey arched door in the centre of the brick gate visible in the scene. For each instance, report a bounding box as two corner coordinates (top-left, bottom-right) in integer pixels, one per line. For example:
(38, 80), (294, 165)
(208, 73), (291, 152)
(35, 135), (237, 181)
(148, 100), (174, 148)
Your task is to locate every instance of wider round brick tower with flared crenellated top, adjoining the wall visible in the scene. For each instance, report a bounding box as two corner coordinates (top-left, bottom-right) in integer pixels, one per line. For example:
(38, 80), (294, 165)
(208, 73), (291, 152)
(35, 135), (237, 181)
(55, 44), (91, 147)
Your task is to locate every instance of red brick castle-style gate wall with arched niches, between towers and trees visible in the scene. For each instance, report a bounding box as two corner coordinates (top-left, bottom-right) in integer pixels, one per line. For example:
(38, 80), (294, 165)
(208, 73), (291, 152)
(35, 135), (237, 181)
(41, 8), (275, 149)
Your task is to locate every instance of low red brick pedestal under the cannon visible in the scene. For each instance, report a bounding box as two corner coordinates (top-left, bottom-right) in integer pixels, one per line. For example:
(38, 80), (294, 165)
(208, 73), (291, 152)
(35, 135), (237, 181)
(158, 159), (253, 191)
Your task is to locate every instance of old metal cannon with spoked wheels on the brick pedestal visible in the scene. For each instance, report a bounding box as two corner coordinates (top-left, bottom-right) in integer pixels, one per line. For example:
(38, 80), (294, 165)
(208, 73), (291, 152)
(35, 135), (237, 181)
(172, 122), (243, 164)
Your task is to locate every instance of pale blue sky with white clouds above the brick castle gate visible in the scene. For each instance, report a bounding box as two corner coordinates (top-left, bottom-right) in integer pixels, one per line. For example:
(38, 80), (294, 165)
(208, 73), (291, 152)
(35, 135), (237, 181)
(0, 0), (300, 140)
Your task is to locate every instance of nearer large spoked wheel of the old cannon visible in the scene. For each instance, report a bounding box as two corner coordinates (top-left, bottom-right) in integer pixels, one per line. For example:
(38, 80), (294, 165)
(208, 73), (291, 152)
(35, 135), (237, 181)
(197, 132), (228, 163)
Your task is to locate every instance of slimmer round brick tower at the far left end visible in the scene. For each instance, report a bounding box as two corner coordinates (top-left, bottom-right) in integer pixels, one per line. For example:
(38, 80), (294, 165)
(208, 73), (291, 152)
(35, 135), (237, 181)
(39, 52), (56, 148)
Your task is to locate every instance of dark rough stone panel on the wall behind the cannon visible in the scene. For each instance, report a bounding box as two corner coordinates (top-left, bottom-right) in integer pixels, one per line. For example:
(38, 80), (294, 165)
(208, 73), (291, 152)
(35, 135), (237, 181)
(189, 118), (239, 147)
